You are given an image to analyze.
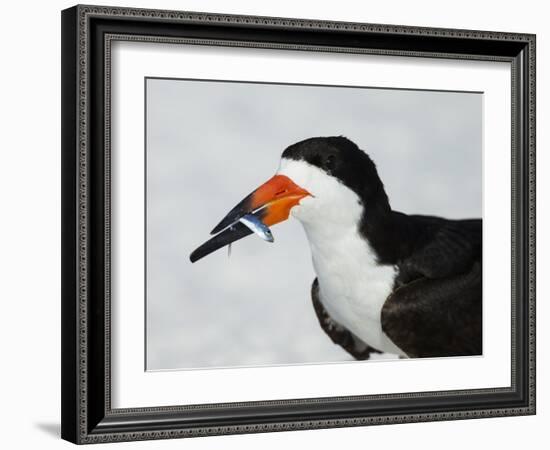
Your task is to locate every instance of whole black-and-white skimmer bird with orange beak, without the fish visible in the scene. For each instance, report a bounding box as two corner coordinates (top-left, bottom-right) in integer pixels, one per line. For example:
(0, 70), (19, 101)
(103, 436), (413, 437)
(190, 136), (482, 359)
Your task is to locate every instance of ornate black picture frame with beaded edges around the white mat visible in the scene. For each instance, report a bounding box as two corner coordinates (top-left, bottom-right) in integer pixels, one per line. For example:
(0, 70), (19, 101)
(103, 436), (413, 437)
(62, 6), (535, 444)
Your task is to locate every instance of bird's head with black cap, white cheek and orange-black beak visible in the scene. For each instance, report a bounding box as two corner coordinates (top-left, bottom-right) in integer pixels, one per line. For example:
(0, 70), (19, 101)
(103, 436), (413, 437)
(191, 136), (389, 261)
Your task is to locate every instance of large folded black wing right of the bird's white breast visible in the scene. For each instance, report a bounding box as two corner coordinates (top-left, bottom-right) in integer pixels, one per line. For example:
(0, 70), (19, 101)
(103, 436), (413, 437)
(381, 216), (482, 357)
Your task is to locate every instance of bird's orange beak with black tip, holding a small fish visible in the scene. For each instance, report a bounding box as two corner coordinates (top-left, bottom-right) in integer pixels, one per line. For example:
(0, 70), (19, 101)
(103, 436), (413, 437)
(190, 175), (311, 262)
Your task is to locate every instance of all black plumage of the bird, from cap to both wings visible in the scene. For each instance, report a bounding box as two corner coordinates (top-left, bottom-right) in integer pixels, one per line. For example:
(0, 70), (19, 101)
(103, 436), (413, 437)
(283, 137), (482, 359)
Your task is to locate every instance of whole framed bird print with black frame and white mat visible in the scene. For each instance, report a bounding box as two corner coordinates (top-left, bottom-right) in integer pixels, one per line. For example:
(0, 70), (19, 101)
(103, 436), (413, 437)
(62, 6), (535, 443)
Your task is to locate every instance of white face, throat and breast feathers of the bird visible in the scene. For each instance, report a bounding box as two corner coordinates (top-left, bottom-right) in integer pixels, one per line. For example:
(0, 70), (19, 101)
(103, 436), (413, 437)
(278, 159), (404, 355)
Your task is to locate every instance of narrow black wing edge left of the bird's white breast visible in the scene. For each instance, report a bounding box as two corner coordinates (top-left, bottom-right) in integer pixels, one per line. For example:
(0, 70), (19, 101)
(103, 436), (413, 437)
(311, 278), (380, 360)
